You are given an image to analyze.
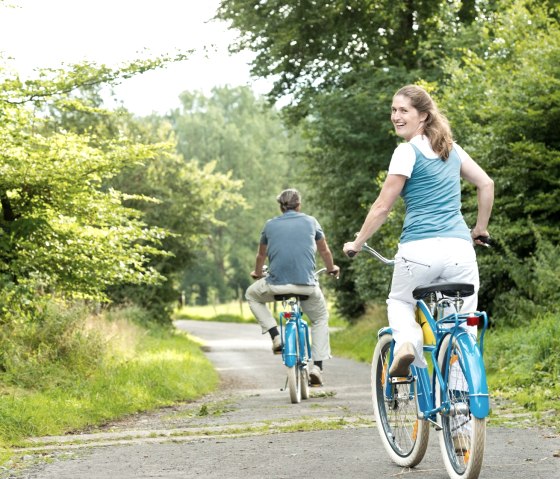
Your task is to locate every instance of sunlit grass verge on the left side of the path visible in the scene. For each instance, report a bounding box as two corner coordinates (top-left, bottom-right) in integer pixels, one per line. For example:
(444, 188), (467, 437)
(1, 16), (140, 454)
(0, 310), (218, 448)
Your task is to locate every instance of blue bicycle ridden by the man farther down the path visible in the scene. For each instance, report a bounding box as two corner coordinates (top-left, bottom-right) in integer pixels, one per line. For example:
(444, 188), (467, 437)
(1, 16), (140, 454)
(274, 268), (327, 404)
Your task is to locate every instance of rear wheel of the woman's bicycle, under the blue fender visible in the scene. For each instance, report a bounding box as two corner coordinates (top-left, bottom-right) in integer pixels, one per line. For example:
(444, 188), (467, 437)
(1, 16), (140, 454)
(435, 334), (486, 479)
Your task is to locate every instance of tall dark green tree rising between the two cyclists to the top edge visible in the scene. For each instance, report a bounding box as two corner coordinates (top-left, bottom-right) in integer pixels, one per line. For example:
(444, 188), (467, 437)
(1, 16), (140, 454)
(218, 0), (491, 317)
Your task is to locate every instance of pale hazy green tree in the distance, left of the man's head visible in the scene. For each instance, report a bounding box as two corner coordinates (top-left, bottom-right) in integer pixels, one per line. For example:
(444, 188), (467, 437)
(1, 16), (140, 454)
(170, 87), (301, 304)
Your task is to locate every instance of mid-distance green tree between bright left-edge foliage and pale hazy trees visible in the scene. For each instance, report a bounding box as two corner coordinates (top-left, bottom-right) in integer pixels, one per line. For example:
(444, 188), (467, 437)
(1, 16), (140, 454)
(110, 116), (245, 320)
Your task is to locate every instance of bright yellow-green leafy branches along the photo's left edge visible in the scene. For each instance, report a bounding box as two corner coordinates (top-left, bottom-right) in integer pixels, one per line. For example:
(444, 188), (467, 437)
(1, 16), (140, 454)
(0, 62), (188, 299)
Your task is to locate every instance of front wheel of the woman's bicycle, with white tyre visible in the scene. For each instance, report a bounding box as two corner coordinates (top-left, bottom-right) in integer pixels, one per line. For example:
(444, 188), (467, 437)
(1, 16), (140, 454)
(371, 334), (430, 467)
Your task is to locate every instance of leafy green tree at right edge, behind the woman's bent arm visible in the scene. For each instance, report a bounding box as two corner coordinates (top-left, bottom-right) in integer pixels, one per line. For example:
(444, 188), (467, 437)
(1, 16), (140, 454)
(441, 0), (560, 321)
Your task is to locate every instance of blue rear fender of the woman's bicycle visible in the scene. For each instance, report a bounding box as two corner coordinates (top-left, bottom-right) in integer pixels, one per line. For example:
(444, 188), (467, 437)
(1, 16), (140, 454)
(455, 331), (490, 419)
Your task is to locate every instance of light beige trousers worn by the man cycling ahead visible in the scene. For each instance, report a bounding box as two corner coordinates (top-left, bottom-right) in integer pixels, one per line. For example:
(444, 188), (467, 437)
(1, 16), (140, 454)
(245, 278), (331, 361)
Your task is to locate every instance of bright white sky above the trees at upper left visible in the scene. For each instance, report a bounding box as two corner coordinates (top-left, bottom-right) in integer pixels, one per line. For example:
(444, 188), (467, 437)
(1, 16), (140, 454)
(0, 0), (270, 115)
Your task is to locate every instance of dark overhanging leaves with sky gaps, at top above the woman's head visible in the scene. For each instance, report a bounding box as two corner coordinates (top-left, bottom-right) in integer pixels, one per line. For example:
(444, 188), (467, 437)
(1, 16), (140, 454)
(218, 0), (480, 118)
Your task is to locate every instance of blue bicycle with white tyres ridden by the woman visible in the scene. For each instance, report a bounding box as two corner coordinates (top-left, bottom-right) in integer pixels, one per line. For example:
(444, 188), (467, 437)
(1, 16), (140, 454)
(349, 244), (490, 479)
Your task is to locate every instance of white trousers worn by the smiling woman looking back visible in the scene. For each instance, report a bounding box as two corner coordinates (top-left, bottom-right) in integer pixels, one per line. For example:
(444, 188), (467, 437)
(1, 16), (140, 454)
(387, 238), (479, 367)
